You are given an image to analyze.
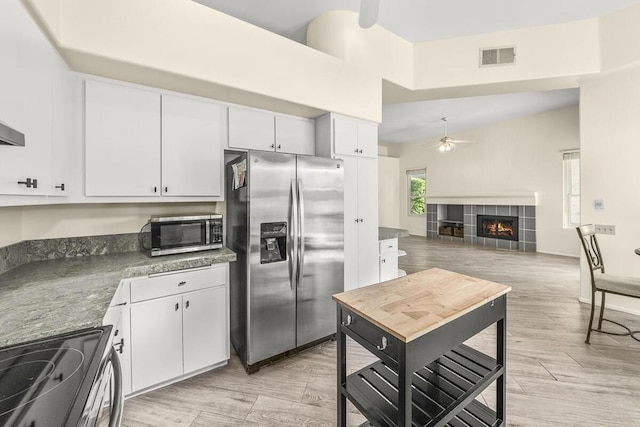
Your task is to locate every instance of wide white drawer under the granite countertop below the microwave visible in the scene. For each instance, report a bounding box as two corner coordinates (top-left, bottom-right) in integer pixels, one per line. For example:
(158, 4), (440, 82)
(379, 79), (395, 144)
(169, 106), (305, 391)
(131, 265), (227, 303)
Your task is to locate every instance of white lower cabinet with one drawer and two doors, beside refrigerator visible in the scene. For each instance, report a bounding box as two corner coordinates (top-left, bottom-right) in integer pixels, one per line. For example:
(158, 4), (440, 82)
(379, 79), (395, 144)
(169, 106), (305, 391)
(130, 263), (229, 393)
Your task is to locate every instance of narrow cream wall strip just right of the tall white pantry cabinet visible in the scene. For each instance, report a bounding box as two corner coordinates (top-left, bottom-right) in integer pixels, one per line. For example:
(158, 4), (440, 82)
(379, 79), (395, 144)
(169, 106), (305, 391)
(378, 155), (401, 228)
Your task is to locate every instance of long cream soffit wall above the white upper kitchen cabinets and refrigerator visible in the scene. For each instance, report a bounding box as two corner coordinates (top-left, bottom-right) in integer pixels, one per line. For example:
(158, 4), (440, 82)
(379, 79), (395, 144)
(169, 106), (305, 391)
(25, 0), (381, 122)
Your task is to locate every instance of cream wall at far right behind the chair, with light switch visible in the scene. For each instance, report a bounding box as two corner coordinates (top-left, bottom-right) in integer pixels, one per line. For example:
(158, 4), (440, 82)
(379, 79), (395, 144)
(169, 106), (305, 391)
(580, 66), (640, 313)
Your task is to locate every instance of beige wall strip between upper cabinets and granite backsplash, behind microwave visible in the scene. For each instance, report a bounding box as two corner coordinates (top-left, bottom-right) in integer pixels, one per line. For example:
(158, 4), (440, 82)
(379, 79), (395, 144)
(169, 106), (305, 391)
(0, 203), (224, 247)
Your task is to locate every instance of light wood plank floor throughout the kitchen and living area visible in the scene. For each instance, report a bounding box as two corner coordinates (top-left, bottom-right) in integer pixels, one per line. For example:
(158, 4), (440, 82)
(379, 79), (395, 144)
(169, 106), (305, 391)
(123, 236), (640, 427)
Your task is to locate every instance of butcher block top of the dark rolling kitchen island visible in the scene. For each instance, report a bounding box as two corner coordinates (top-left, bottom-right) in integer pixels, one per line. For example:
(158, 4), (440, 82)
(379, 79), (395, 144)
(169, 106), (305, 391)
(333, 268), (511, 343)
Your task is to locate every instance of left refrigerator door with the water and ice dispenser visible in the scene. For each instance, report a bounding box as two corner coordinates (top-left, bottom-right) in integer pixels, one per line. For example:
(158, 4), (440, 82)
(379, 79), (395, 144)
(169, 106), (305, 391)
(247, 152), (296, 365)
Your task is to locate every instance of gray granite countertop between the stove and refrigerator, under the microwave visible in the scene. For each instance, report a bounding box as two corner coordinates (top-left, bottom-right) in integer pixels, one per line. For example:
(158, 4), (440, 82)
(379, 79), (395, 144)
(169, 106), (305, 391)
(0, 248), (236, 347)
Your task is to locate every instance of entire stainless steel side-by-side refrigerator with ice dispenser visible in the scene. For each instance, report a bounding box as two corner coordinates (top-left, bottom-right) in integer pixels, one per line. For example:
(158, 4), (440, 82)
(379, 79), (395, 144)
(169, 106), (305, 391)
(225, 151), (344, 373)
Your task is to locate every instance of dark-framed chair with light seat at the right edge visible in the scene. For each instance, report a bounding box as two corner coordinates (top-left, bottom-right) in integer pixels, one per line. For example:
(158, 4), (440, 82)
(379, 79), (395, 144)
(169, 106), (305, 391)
(576, 224), (640, 344)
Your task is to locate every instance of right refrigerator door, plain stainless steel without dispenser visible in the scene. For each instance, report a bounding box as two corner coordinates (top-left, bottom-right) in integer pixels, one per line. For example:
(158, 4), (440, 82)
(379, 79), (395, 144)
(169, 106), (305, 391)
(297, 156), (344, 346)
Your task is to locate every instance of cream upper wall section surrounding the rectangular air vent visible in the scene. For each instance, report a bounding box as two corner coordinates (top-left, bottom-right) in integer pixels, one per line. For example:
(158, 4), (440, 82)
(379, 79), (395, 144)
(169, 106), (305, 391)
(414, 19), (600, 89)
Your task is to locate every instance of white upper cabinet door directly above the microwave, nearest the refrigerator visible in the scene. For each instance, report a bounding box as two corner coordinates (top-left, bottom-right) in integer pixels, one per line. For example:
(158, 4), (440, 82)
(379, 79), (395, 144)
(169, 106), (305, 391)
(162, 95), (226, 196)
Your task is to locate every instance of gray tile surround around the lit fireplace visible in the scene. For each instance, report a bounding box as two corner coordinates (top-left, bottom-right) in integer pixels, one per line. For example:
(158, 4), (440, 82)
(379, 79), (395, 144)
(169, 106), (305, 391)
(427, 203), (536, 252)
